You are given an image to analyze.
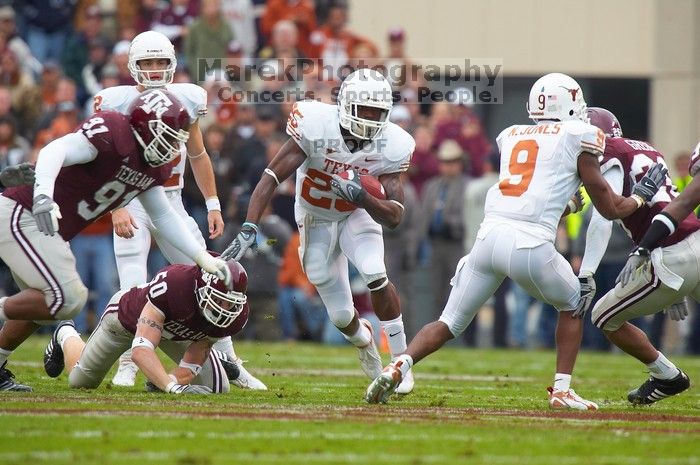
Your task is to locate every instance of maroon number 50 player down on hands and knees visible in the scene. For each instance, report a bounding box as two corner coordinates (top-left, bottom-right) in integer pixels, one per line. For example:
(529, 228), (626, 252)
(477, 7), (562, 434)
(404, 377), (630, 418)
(44, 261), (250, 394)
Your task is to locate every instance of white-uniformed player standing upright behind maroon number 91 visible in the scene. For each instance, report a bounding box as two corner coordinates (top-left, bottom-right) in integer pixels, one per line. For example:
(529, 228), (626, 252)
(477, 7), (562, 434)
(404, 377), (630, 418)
(94, 31), (267, 390)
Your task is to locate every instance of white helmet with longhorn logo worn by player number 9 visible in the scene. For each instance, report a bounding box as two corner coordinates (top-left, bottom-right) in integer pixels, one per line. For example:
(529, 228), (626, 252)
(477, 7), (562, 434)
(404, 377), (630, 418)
(527, 73), (588, 122)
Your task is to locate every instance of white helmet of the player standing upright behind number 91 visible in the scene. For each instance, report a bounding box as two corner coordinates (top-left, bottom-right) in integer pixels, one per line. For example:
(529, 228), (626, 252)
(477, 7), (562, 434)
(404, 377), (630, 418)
(128, 31), (177, 89)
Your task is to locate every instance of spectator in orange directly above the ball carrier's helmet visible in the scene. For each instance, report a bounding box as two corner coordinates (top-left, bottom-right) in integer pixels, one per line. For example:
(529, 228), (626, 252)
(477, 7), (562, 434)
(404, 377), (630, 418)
(310, 3), (379, 80)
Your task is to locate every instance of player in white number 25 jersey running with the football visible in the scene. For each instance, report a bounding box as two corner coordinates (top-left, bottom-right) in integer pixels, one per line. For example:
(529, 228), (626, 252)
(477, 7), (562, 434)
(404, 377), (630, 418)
(222, 69), (415, 393)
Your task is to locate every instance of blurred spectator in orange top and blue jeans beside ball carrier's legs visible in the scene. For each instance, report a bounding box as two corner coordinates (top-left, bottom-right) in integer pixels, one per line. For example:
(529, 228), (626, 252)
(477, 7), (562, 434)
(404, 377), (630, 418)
(277, 231), (326, 341)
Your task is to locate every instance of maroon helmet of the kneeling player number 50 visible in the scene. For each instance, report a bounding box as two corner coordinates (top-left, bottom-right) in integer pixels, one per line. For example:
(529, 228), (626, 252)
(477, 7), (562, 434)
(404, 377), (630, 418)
(195, 260), (248, 328)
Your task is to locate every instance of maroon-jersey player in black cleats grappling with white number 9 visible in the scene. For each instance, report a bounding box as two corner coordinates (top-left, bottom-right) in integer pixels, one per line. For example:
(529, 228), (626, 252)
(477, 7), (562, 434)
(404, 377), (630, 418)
(579, 108), (700, 404)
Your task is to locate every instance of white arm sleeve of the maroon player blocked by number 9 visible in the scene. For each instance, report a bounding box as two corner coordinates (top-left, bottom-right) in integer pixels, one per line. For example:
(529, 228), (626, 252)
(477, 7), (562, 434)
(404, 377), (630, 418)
(579, 166), (624, 276)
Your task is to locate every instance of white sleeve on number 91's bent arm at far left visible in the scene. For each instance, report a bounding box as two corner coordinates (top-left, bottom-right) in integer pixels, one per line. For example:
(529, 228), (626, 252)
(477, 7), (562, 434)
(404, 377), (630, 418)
(34, 132), (97, 198)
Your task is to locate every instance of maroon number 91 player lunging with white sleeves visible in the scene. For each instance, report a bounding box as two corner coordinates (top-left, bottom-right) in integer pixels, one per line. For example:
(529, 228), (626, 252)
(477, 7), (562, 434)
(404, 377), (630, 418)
(0, 89), (226, 389)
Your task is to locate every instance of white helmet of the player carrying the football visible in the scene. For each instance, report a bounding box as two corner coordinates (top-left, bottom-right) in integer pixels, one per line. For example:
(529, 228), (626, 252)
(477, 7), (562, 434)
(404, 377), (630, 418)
(338, 68), (394, 139)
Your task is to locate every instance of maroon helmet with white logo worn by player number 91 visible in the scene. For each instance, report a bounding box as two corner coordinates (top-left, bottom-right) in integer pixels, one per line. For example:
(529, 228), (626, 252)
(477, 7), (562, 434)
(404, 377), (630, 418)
(129, 89), (190, 166)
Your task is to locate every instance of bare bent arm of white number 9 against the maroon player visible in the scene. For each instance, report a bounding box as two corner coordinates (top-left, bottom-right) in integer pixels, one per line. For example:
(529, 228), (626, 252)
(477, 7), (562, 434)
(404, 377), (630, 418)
(578, 152), (644, 220)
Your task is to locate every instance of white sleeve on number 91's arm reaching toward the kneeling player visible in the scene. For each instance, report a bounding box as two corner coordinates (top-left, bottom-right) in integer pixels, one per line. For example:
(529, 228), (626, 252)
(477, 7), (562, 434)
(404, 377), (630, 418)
(138, 186), (204, 260)
